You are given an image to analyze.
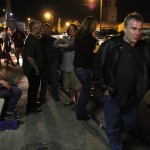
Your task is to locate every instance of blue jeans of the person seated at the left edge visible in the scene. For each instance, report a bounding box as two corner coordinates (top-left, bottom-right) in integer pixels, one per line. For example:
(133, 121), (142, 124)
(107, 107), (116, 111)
(0, 86), (22, 112)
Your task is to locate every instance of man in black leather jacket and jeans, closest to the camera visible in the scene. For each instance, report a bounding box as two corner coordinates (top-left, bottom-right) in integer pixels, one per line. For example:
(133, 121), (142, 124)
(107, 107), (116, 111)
(93, 13), (150, 150)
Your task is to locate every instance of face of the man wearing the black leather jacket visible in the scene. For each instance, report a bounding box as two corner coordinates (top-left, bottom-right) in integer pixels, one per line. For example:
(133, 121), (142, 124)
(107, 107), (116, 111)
(124, 19), (143, 45)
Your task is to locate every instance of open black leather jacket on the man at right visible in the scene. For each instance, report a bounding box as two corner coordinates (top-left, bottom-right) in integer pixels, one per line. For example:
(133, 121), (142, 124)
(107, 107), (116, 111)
(93, 35), (150, 99)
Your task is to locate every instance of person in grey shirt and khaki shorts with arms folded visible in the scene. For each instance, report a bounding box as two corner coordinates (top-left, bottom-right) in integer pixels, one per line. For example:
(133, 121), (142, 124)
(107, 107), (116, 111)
(61, 24), (81, 107)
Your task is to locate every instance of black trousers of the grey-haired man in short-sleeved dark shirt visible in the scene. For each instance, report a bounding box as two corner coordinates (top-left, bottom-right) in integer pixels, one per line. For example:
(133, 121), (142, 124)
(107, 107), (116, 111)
(26, 74), (40, 110)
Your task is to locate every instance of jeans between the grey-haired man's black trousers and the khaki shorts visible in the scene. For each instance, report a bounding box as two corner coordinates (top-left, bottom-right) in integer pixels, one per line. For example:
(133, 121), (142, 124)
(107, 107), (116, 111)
(48, 61), (58, 97)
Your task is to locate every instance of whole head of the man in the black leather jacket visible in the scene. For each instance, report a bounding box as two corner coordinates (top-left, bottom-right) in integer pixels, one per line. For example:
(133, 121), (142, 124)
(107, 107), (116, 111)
(124, 12), (143, 46)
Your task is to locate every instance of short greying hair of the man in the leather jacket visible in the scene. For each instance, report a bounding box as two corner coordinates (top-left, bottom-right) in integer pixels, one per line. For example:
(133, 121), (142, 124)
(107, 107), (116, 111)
(124, 12), (143, 27)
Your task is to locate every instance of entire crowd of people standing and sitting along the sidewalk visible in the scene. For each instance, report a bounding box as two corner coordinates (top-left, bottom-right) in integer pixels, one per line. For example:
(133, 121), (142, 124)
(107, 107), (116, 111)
(0, 12), (150, 150)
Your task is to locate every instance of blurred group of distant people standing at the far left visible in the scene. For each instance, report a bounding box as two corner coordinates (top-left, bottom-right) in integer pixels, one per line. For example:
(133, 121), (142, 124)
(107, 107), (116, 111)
(0, 26), (26, 69)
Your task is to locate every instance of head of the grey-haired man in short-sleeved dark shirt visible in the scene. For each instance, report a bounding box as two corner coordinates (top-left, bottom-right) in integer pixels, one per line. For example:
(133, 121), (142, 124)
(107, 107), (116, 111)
(29, 20), (41, 36)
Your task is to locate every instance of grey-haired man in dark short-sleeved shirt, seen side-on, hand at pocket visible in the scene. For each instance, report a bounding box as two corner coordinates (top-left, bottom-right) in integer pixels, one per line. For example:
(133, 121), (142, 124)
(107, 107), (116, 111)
(22, 20), (43, 113)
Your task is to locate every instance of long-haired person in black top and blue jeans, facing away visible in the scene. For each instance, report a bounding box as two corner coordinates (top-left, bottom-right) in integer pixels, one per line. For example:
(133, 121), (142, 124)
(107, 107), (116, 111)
(74, 16), (97, 120)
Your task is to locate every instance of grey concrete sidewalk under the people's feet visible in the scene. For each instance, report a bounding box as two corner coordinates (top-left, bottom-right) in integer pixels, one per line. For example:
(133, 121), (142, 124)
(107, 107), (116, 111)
(0, 56), (149, 150)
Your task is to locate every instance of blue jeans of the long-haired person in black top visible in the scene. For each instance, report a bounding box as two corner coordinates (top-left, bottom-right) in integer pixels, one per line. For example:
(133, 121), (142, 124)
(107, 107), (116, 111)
(75, 68), (91, 120)
